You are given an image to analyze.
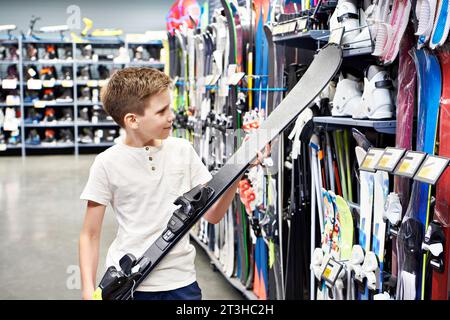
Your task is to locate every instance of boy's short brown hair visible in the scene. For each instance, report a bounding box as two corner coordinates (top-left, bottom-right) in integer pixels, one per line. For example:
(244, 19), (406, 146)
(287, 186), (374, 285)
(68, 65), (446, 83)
(100, 68), (172, 128)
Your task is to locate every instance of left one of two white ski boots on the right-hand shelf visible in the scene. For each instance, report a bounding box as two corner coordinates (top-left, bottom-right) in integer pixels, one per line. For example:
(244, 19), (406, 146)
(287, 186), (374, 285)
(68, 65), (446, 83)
(331, 75), (362, 117)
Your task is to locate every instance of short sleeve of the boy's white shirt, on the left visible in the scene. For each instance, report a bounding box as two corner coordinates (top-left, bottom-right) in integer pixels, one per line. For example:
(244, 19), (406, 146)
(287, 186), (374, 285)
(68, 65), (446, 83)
(80, 157), (112, 206)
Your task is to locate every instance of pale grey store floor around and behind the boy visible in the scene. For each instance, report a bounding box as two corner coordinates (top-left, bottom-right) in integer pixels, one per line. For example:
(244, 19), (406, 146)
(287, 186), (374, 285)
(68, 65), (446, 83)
(0, 155), (243, 300)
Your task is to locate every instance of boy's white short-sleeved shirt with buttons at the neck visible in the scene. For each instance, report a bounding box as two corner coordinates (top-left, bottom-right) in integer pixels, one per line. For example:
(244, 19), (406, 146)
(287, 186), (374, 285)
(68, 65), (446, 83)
(80, 137), (212, 291)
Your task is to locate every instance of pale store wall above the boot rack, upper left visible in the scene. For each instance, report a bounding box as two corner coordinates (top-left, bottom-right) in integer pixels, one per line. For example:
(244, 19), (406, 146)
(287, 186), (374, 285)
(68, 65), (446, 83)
(0, 0), (173, 34)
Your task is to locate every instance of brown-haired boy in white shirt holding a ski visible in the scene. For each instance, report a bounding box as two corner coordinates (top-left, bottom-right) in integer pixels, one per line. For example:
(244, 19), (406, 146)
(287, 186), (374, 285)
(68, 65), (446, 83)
(79, 68), (262, 300)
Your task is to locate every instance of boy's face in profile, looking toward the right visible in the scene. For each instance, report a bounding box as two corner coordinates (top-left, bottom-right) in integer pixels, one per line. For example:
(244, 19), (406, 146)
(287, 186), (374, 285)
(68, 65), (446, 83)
(137, 89), (175, 142)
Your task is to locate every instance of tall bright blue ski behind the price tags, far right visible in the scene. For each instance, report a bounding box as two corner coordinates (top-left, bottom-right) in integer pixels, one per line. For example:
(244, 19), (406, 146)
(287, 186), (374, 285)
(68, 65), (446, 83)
(396, 49), (441, 300)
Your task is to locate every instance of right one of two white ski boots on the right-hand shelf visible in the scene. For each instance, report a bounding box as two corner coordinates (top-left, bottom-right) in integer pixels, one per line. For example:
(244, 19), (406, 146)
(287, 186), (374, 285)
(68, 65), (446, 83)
(353, 65), (394, 120)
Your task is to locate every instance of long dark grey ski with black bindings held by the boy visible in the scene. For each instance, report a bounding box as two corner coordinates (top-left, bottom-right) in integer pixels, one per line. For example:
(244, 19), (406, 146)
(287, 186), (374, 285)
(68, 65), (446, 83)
(95, 44), (342, 300)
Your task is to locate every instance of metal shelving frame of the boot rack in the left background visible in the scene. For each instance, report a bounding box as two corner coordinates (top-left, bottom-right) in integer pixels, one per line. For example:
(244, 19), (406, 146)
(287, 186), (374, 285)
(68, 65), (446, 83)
(0, 38), (164, 156)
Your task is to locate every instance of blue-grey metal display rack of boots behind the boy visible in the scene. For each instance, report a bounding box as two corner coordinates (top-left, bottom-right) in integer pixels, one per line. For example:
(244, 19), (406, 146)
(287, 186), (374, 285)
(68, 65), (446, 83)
(0, 38), (164, 156)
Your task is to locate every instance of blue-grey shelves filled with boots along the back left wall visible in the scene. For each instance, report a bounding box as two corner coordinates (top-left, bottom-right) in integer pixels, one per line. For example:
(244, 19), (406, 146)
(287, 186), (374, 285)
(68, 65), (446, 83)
(0, 38), (164, 156)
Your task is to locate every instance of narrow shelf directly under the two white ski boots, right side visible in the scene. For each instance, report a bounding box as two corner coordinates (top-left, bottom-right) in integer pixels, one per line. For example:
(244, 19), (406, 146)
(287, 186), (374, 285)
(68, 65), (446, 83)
(313, 117), (397, 134)
